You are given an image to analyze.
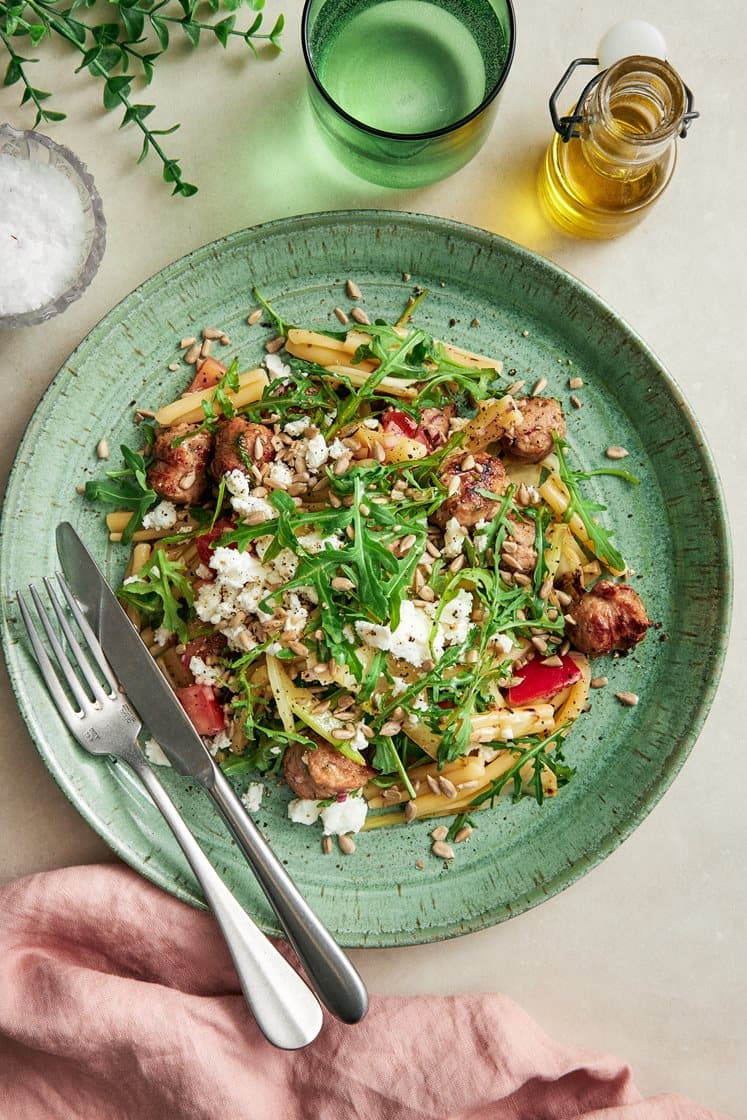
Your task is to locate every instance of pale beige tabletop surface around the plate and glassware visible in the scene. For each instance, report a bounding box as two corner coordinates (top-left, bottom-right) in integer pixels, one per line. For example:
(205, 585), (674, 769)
(0, 0), (747, 1117)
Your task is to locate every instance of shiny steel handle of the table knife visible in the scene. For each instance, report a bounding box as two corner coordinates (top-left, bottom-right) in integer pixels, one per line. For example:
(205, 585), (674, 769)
(207, 766), (368, 1023)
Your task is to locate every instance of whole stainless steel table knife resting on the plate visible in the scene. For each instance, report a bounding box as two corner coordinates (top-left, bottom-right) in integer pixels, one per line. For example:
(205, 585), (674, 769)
(56, 522), (368, 1023)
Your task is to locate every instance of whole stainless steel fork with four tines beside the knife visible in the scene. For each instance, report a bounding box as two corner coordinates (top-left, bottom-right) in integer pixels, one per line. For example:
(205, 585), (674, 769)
(17, 575), (323, 1049)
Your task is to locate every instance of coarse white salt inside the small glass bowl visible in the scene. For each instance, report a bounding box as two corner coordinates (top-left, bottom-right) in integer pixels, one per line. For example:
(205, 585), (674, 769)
(0, 155), (86, 315)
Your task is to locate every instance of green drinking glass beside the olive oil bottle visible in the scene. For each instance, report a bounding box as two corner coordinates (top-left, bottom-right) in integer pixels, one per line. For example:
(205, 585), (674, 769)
(301, 0), (515, 187)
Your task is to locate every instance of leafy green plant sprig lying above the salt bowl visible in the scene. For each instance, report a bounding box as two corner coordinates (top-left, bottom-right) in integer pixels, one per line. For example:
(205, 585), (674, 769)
(0, 0), (284, 198)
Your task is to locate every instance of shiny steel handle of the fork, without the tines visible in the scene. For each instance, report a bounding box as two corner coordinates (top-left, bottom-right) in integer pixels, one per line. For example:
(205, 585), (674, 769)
(128, 756), (323, 1049)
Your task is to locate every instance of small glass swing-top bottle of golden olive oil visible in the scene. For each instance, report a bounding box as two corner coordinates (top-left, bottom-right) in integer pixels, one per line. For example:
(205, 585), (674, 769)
(539, 55), (697, 237)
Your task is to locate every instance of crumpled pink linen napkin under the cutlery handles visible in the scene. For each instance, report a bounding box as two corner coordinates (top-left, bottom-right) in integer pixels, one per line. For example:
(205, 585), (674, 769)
(0, 866), (734, 1120)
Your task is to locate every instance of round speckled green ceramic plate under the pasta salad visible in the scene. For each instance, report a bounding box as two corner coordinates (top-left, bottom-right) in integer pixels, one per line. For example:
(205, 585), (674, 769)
(2, 211), (730, 946)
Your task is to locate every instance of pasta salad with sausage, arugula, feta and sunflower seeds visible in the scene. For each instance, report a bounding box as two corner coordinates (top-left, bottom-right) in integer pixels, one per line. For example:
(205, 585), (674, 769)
(85, 288), (650, 859)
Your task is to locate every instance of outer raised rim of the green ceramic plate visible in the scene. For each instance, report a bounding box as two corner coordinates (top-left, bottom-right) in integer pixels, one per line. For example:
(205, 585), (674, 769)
(0, 208), (734, 948)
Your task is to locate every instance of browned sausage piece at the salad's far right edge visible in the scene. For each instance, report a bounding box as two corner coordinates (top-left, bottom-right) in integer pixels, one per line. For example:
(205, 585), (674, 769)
(567, 579), (651, 657)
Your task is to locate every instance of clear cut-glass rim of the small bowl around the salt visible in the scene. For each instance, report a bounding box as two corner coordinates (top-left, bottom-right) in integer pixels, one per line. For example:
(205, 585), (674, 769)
(0, 124), (106, 330)
